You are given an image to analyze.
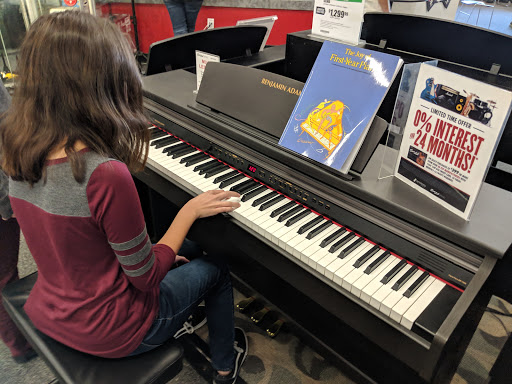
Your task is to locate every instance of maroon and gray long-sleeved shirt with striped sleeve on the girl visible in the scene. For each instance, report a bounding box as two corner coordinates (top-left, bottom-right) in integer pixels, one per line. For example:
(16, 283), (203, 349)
(10, 150), (175, 358)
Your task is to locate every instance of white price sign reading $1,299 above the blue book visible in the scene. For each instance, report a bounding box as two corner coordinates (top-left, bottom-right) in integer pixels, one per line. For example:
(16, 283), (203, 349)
(312, 0), (364, 45)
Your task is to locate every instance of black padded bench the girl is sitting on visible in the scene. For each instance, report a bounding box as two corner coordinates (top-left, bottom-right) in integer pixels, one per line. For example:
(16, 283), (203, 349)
(2, 272), (183, 384)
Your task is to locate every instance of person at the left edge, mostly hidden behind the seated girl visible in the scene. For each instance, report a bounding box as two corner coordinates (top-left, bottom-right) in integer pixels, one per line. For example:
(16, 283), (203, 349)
(0, 82), (36, 363)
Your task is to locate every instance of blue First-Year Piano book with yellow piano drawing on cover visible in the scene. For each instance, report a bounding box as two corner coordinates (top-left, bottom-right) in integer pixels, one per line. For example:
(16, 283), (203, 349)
(279, 41), (402, 174)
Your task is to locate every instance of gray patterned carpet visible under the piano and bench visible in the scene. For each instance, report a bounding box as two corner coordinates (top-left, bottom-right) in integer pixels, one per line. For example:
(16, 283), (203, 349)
(0, 234), (512, 384)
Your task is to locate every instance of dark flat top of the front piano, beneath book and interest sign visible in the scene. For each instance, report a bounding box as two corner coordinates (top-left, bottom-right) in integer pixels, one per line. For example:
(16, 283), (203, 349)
(143, 70), (512, 258)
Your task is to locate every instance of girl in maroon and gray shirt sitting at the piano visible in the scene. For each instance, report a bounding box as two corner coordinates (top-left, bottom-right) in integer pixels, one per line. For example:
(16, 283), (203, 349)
(0, 11), (247, 383)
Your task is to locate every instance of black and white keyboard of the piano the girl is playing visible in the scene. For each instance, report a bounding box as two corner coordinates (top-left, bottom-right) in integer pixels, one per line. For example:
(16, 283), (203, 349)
(148, 126), (462, 340)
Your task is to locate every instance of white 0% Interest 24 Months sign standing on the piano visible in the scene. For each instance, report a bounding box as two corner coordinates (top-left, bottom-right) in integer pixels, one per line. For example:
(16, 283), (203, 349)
(395, 64), (512, 220)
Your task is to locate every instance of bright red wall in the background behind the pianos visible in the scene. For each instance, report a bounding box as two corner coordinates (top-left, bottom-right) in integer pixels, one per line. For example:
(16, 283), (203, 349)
(101, 3), (313, 53)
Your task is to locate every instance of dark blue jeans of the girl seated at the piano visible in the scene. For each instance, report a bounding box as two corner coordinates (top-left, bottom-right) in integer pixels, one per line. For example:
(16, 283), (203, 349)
(131, 240), (235, 371)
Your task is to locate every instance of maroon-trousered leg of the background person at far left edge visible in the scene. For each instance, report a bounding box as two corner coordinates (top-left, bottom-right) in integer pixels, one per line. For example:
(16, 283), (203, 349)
(0, 219), (36, 363)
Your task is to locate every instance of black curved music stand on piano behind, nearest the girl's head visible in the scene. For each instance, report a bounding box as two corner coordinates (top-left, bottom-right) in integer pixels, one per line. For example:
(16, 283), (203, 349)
(145, 26), (267, 76)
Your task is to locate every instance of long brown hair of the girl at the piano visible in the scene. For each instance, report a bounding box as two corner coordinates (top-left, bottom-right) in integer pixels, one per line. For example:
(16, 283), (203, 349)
(0, 11), (149, 184)
